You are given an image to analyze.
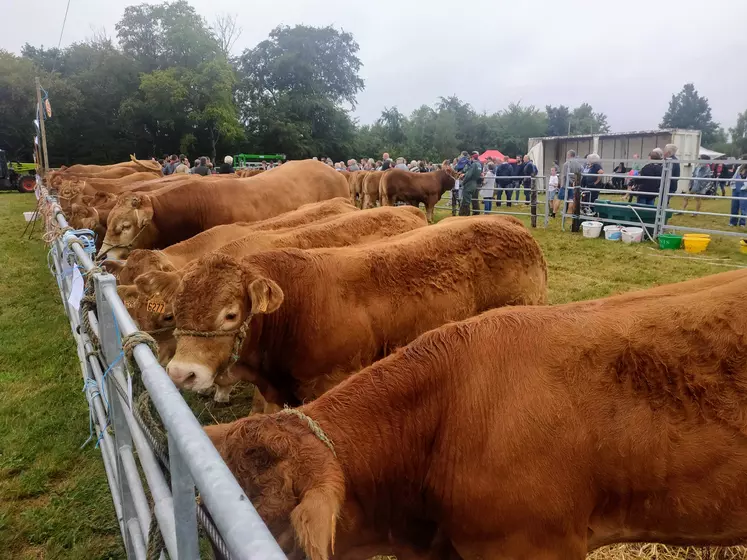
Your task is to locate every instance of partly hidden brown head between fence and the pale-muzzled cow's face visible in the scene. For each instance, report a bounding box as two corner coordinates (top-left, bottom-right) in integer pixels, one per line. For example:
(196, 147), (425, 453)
(117, 285), (176, 366)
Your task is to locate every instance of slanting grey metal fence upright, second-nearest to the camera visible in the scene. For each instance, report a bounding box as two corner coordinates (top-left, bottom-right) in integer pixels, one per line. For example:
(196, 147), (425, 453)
(93, 274), (142, 557)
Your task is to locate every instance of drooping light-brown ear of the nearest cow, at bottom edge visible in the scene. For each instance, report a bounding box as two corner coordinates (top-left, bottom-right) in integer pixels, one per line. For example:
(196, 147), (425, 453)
(291, 485), (342, 560)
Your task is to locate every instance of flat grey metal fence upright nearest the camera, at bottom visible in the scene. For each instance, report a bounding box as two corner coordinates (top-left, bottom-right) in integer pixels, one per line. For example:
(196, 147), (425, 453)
(169, 435), (200, 560)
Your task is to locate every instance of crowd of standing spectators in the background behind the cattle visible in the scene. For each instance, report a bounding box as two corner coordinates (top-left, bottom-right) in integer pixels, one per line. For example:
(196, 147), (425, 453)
(158, 149), (747, 226)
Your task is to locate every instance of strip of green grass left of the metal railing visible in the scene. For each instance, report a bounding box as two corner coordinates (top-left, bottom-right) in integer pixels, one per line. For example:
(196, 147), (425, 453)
(0, 193), (124, 560)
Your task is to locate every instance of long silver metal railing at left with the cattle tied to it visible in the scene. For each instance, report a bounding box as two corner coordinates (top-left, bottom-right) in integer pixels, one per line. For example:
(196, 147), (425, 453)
(37, 181), (285, 560)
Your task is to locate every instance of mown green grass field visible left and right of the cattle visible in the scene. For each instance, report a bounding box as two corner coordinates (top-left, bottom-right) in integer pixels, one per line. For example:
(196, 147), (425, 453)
(0, 193), (747, 560)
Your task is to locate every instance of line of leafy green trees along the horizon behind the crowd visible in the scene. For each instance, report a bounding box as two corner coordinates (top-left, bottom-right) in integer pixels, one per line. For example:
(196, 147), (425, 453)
(0, 0), (747, 165)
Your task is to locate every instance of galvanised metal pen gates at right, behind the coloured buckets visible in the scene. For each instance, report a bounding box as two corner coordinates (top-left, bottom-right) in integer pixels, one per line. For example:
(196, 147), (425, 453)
(561, 159), (747, 240)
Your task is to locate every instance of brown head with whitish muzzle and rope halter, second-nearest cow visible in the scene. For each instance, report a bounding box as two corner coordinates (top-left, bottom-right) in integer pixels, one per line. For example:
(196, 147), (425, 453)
(136, 254), (284, 391)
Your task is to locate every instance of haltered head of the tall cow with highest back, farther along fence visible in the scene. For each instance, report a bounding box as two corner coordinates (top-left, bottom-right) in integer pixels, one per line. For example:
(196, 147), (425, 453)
(98, 193), (158, 260)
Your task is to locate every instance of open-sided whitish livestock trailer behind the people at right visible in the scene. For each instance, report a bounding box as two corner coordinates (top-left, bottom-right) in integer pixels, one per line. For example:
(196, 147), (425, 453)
(527, 128), (700, 191)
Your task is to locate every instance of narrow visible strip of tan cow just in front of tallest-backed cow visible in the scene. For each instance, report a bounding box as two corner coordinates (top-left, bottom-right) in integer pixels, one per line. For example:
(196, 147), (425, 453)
(114, 198), (357, 284)
